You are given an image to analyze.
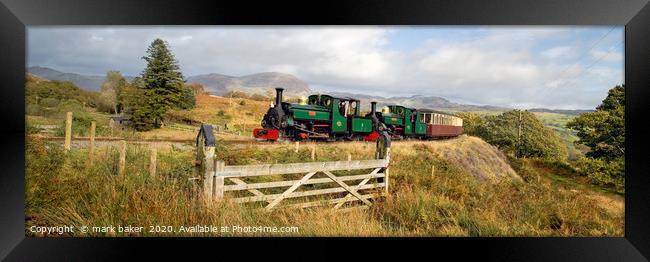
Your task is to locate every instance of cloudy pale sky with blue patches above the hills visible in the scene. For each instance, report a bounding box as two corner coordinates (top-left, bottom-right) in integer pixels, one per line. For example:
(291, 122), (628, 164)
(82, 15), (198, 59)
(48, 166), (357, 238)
(27, 26), (625, 109)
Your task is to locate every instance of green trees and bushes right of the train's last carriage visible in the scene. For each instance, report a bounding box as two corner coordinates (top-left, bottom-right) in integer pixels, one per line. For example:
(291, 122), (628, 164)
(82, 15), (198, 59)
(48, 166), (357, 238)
(457, 85), (625, 192)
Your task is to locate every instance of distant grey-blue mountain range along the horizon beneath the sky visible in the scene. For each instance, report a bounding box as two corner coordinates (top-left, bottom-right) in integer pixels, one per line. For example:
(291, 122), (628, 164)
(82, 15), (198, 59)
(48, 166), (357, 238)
(27, 66), (593, 115)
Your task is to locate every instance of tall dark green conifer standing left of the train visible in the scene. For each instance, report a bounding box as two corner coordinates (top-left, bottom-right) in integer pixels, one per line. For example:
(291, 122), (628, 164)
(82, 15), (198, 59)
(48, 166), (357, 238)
(141, 39), (185, 128)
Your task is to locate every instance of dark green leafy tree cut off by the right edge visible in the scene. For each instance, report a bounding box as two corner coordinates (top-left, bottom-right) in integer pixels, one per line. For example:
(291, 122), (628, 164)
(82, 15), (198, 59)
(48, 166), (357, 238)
(567, 85), (625, 191)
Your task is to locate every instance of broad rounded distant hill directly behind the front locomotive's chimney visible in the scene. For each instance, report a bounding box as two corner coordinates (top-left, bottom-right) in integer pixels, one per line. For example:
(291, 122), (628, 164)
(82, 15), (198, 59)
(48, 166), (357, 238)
(187, 72), (312, 96)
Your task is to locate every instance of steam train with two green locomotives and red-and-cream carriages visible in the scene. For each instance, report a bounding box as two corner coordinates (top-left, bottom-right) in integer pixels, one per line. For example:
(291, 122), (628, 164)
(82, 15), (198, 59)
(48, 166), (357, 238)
(253, 88), (463, 141)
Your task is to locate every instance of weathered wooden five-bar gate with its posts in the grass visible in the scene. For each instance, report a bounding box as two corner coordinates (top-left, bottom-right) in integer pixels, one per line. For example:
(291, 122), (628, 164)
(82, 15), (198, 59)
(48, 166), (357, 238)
(197, 125), (390, 210)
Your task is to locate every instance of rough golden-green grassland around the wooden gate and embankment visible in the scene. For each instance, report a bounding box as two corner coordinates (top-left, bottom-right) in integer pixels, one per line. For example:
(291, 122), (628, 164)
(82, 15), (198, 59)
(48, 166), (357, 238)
(25, 134), (624, 236)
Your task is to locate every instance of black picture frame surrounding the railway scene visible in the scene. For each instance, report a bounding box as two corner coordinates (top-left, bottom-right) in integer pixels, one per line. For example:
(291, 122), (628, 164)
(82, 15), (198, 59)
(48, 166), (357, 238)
(0, 0), (650, 261)
